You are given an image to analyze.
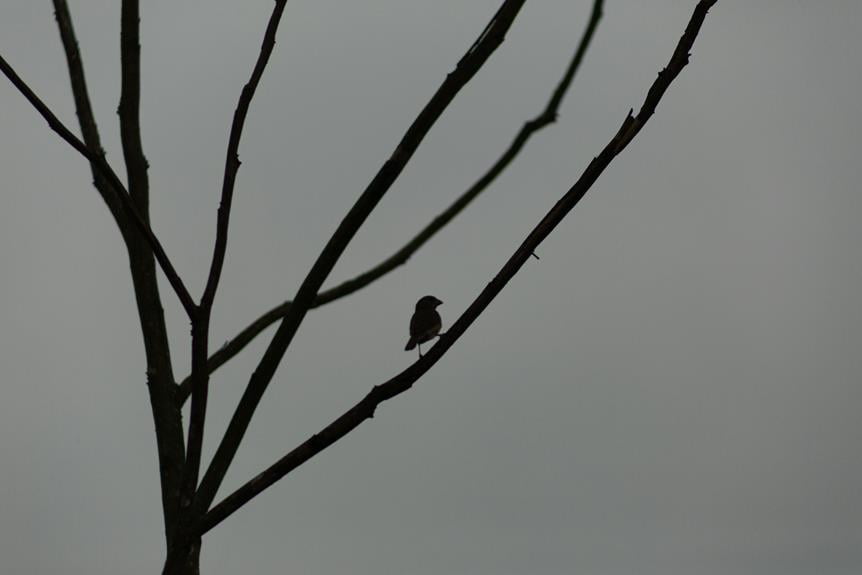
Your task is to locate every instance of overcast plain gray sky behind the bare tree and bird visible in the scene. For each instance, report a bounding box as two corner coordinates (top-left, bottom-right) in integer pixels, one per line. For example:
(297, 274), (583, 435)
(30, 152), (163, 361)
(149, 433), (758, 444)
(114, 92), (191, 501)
(0, 0), (862, 575)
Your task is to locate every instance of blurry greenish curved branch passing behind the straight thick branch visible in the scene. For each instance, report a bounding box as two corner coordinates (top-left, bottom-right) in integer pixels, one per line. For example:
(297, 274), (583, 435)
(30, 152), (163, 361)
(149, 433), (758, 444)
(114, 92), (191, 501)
(177, 0), (604, 405)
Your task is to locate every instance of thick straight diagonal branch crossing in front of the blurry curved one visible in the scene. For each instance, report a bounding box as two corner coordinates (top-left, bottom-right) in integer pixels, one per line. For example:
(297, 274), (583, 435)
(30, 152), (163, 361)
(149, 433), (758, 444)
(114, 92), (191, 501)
(195, 0), (525, 513)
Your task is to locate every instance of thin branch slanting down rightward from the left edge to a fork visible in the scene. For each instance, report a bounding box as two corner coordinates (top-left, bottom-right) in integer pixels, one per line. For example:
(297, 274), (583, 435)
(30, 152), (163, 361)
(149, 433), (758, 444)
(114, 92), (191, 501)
(0, 56), (196, 316)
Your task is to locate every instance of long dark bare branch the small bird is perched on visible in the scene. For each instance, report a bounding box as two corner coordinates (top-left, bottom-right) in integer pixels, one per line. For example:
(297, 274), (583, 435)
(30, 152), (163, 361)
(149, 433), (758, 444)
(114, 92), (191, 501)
(196, 0), (717, 534)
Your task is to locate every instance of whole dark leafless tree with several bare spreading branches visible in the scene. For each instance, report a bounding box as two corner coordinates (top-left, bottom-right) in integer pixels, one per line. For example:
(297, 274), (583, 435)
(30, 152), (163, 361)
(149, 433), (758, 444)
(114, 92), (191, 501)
(0, 0), (717, 574)
